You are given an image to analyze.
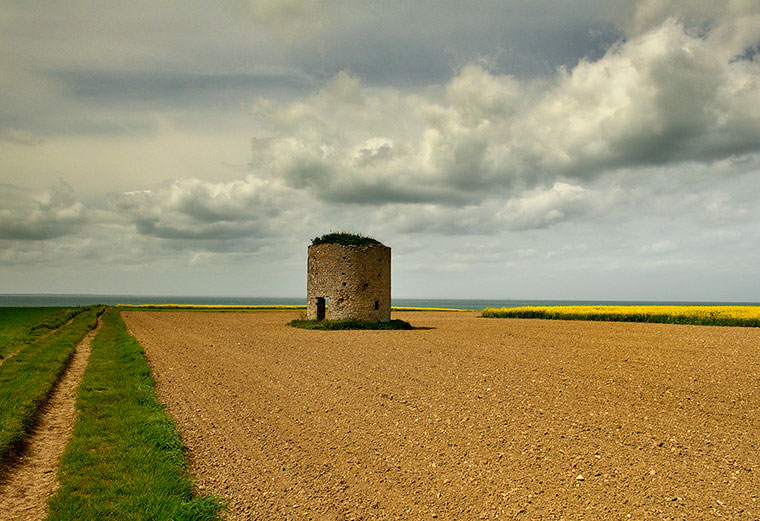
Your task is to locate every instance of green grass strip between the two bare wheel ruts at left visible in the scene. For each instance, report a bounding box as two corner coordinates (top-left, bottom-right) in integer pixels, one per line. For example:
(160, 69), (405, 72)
(0, 307), (103, 464)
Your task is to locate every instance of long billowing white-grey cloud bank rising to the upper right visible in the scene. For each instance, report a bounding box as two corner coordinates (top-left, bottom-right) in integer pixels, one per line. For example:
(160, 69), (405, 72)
(252, 13), (760, 205)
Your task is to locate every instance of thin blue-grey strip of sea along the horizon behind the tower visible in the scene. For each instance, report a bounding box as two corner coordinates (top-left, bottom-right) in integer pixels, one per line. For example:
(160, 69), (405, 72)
(0, 293), (760, 310)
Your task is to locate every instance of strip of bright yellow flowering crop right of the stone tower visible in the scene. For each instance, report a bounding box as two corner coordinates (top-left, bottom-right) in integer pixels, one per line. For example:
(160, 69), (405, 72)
(482, 306), (760, 327)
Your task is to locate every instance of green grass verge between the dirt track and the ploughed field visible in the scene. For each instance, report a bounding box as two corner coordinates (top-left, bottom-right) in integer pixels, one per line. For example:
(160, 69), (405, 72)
(48, 308), (221, 521)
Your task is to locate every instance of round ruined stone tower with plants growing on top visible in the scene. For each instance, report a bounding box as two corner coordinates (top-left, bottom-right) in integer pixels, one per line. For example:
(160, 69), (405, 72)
(306, 233), (391, 322)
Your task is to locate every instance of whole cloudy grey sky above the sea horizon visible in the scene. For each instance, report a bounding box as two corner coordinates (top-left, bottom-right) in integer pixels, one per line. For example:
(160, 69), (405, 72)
(0, 0), (760, 302)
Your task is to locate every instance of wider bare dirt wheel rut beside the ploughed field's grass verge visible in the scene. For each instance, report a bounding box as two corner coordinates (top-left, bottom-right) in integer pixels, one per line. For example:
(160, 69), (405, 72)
(0, 322), (100, 521)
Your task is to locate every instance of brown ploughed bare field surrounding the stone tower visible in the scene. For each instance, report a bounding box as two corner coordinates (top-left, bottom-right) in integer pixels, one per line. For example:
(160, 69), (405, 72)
(122, 311), (760, 520)
